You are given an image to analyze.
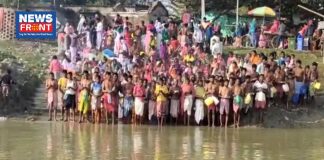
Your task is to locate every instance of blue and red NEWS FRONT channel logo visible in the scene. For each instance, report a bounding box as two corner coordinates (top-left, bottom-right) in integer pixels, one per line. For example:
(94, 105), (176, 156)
(16, 11), (56, 39)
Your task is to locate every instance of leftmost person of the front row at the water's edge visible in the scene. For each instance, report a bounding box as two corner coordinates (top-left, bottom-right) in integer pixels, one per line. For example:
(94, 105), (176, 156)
(46, 72), (58, 121)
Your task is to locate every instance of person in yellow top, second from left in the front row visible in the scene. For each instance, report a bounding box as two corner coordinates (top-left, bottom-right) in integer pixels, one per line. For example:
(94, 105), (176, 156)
(57, 70), (68, 121)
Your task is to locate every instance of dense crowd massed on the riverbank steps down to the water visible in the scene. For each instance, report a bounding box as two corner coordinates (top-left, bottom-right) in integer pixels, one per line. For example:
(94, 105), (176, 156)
(46, 15), (320, 127)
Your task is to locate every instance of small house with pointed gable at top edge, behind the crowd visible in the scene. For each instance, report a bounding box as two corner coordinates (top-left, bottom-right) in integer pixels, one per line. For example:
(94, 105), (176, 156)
(148, 1), (169, 20)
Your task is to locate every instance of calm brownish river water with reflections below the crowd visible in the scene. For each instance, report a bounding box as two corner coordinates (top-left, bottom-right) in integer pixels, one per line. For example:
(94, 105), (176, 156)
(0, 121), (324, 160)
